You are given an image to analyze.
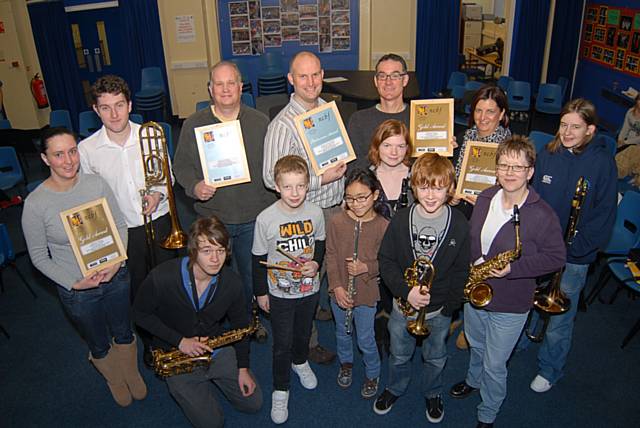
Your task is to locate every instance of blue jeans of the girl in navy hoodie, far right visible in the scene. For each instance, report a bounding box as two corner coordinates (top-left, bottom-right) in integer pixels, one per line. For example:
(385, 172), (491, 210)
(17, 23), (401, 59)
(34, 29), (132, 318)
(531, 263), (589, 385)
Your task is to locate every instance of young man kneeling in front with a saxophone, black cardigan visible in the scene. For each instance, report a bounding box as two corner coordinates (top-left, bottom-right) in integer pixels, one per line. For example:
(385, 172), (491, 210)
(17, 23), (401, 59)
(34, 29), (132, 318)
(134, 217), (262, 427)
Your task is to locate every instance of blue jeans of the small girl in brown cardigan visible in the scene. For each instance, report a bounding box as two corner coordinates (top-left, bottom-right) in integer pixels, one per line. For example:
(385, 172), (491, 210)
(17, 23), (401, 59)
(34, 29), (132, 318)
(331, 300), (380, 379)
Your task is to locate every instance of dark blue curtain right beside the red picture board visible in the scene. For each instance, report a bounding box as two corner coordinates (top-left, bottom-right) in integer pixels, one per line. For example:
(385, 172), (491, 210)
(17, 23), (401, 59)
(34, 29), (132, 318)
(547, 0), (584, 99)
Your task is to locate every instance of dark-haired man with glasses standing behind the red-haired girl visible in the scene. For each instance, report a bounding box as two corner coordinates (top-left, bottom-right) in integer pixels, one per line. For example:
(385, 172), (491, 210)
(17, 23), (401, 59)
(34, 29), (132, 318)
(348, 53), (409, 168)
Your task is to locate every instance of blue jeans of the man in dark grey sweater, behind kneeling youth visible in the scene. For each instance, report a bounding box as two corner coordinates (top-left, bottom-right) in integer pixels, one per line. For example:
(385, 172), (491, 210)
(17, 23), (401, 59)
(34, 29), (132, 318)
(224, 221), (256, 313)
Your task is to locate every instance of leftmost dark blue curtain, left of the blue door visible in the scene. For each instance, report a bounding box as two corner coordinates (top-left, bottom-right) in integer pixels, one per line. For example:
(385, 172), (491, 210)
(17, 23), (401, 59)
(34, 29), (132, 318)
(28, 1), (88, 129)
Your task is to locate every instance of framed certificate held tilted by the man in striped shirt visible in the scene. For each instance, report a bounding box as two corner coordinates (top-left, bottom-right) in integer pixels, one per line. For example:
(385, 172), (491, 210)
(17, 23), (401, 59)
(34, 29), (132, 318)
(294, 101), (356, 175)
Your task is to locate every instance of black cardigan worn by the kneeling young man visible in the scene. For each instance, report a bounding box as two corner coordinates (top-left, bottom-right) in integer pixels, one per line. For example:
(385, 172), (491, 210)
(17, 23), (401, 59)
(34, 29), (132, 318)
(133, 258), (249, 368)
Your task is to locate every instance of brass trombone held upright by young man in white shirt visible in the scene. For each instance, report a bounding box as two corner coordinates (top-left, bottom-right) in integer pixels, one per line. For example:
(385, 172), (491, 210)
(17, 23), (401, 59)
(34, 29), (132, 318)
(138, 122), (187, 267)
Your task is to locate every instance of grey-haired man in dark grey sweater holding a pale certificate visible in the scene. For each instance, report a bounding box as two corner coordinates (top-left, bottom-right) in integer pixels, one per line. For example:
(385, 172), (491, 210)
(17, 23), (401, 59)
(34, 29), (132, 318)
(173, 61), (275, 343)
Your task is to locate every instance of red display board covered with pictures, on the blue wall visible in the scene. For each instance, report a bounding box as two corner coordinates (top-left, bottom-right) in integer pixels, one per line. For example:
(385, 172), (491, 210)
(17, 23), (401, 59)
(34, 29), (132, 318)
(580, 3), (640, 77)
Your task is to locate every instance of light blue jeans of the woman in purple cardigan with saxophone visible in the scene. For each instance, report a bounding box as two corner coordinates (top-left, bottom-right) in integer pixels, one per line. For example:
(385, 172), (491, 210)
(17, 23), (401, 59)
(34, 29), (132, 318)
(464, 303), (528, 423)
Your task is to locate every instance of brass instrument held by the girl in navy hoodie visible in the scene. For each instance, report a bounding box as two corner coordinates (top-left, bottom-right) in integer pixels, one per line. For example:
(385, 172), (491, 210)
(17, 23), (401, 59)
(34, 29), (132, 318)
(526, 177), (588, 343)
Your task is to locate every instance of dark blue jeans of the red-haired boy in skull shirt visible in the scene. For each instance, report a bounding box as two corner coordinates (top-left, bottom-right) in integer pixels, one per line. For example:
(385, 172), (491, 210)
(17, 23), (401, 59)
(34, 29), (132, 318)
(387, 304), (451, 398)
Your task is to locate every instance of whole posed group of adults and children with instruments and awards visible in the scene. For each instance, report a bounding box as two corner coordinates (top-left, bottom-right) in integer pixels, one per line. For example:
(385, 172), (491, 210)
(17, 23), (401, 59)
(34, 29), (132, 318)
(22, 52), (617, 427)
